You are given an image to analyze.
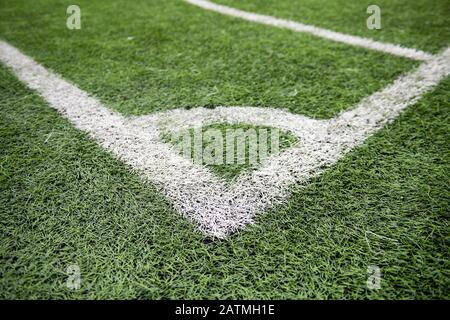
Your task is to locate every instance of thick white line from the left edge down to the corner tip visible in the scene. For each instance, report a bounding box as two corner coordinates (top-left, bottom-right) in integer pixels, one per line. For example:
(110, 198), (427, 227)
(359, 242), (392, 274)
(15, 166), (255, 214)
(0, 41), (232, 237)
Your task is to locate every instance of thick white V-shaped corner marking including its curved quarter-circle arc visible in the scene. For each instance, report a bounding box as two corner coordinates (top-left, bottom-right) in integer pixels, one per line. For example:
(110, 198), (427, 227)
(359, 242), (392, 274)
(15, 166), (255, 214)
(0, 41), (450, 238)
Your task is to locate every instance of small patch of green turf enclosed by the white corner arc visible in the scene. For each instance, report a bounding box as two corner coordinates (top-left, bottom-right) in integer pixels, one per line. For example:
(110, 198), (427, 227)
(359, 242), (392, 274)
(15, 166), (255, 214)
(162, 123), (298, 181)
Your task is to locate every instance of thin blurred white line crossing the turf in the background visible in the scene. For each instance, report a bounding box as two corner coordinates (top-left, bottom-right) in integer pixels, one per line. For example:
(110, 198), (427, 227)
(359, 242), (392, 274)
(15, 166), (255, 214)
(184, 0), (432, 61)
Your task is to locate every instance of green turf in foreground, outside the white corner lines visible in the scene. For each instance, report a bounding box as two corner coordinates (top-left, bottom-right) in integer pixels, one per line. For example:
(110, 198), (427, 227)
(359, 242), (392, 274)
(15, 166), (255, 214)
(0, 63), (450, 299)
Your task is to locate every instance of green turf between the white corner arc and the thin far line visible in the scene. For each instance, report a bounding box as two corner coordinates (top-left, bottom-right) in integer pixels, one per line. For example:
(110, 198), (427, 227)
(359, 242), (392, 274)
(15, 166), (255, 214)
(0, 0), (418, 118)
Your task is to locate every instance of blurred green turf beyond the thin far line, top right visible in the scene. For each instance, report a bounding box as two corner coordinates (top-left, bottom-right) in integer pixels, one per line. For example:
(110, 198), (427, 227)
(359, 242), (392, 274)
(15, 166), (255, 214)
(216, 0), (450, 52)
